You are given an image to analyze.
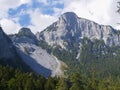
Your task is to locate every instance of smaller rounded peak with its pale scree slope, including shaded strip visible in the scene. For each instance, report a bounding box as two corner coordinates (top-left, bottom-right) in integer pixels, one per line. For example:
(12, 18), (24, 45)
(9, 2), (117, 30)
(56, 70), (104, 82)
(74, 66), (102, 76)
(11, 28), (62, 77)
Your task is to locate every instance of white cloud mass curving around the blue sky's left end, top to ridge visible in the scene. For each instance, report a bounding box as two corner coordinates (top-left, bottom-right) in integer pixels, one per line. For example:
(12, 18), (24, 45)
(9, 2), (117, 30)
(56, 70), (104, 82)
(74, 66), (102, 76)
(0, 0), (31, 34)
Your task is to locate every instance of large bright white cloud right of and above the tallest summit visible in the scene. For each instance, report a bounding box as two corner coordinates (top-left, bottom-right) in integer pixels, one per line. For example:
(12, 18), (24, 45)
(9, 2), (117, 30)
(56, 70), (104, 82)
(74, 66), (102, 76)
(62, 0), (120, 27)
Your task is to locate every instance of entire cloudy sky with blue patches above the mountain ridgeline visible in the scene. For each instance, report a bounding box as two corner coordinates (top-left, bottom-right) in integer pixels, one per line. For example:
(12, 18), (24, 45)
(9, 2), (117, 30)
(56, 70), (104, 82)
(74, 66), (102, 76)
(0, 0), (120, 34)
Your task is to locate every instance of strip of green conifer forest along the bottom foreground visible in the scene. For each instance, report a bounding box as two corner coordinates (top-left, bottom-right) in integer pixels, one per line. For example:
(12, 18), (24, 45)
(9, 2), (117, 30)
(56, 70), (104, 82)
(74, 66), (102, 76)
(0, 66), (120, 90)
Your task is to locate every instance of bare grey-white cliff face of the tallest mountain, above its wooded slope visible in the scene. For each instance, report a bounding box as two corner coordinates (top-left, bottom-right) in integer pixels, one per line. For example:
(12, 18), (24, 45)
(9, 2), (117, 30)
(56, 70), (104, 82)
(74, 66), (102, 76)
(37, 12), (120, 48)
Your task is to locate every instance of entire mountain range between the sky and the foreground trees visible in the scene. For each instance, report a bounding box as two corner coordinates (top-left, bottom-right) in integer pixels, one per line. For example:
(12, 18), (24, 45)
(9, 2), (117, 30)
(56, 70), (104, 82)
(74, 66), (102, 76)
(0, 12), (120, 77)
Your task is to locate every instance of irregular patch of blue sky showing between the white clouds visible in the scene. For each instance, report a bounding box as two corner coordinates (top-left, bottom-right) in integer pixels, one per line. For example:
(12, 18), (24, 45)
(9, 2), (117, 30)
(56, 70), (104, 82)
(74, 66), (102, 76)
(8, 0), (64, 27)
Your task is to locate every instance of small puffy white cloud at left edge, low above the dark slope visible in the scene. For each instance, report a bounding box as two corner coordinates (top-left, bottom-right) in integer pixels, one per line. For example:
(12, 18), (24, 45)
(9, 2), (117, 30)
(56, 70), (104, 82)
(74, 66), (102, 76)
(0, 18), (20, 34)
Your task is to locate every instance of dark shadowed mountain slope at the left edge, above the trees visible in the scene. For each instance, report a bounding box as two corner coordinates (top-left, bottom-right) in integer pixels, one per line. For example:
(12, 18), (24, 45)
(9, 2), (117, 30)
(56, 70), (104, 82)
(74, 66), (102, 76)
(0, 27), (32, 71)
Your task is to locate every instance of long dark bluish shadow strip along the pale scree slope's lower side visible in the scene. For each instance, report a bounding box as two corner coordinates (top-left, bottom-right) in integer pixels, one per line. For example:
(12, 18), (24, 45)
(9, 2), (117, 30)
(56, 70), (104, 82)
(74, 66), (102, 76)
(17, 49), (51, 77)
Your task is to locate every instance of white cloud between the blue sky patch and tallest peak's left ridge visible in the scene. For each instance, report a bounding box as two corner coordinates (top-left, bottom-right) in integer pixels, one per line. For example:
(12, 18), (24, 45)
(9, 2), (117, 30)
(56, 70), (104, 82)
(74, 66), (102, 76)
(29, 9), (57, 33)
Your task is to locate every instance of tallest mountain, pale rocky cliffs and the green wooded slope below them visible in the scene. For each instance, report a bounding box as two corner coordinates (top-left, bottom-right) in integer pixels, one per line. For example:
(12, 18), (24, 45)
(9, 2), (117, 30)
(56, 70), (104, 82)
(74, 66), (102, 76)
(36, 12), (120, 77)
